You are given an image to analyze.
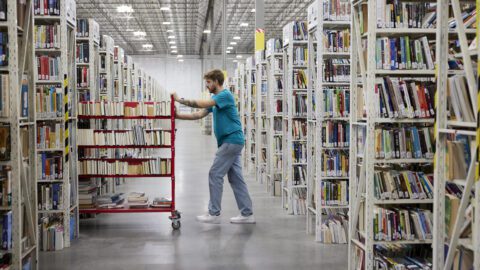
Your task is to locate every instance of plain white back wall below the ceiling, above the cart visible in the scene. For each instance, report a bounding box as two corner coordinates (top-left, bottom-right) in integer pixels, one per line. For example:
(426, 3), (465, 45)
(132, 55), (236, 98)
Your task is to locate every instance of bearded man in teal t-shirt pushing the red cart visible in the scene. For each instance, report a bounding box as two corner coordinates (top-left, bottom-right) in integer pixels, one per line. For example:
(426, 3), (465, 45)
(172, 69), (255, 224)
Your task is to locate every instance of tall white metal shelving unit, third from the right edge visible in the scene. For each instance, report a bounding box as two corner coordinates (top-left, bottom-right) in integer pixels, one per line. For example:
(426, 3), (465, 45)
(307, 0), (351, 244)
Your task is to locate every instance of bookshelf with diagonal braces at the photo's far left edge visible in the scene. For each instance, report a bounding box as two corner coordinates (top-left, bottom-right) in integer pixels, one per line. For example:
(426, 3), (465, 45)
(0, 1), (38, 269)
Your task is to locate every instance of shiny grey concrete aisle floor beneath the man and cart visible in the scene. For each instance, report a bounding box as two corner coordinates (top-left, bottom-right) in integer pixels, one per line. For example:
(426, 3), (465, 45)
(40, 122), (347, 270)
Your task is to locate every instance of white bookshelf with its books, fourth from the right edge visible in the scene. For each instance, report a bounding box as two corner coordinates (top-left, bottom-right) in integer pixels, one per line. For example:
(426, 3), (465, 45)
(282, 21), (308, 215)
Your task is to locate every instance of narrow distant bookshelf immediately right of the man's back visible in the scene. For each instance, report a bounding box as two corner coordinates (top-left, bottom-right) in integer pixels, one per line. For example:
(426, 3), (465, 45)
(245, 56), (257, 174)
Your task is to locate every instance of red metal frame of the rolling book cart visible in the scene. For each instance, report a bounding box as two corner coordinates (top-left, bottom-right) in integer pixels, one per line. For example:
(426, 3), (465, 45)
(77, 97), (181, 230)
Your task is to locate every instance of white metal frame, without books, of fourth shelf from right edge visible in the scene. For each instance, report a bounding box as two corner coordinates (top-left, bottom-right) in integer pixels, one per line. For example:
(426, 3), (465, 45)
(282, 21), (309, 214)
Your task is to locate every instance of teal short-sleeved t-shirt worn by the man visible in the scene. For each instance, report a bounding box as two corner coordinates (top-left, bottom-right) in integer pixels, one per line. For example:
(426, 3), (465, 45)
(208, 89), (245, 147)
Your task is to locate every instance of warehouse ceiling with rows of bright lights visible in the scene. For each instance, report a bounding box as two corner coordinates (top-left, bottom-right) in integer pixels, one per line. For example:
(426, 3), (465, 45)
(77, 0), (311, 55)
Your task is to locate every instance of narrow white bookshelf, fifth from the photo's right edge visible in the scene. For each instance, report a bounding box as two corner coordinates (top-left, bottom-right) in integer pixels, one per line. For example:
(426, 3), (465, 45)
(266, 39), (284, 196)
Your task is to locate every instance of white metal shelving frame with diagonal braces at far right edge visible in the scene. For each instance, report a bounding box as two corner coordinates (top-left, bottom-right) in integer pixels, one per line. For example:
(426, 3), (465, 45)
(433, 0), (480, 269)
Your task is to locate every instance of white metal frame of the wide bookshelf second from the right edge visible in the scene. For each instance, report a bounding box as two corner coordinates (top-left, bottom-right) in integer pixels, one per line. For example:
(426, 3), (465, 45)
(348, 0), (438, 269)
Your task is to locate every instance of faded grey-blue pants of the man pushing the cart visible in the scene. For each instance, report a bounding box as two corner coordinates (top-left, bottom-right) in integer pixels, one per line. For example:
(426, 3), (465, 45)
(208, 143), (253, 216)
